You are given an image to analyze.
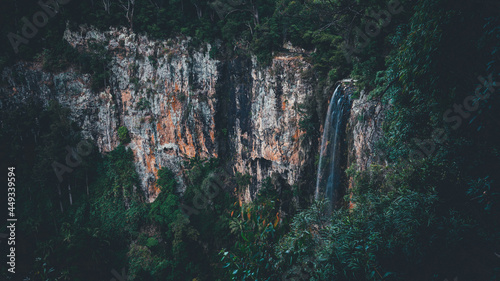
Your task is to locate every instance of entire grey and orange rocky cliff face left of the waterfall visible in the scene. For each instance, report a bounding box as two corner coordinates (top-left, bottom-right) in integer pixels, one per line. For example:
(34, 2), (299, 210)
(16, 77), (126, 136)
(1, 27), (314, 201)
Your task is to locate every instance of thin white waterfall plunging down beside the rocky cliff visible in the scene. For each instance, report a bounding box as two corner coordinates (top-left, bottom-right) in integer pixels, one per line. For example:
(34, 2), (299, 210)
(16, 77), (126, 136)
(315, 85), (349, 206)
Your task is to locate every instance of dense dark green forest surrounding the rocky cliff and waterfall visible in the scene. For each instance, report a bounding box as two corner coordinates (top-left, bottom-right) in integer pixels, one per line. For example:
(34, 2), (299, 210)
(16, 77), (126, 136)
(0, 0), (500, 281)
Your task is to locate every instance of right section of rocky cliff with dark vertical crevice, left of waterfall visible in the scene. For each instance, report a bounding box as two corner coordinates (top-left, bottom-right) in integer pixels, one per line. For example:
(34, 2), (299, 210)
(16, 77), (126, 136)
(220, 53), (313, 200)
